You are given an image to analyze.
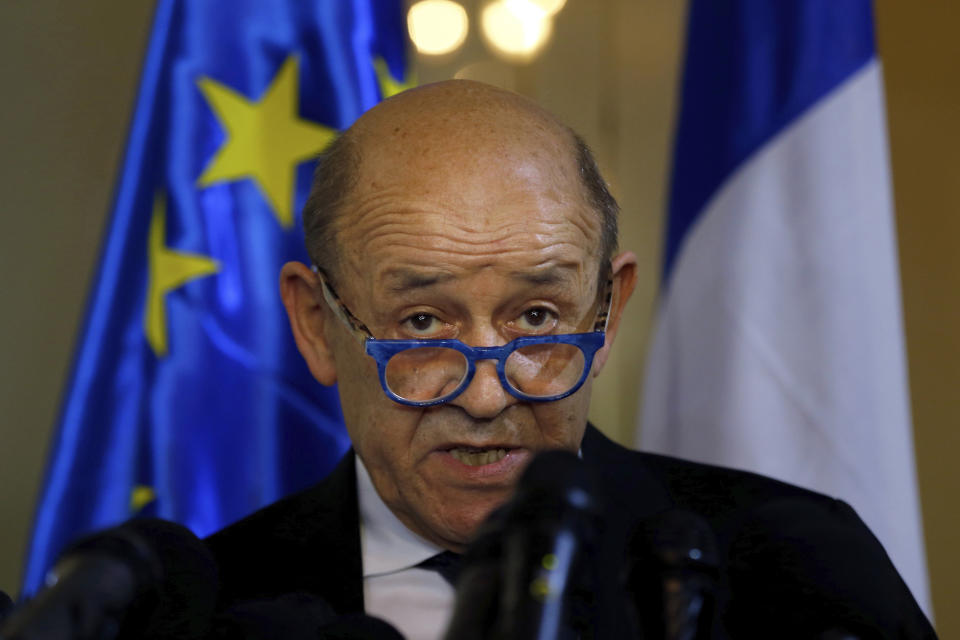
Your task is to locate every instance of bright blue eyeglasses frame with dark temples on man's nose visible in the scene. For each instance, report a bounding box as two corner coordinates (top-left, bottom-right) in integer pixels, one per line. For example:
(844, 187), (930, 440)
(311, 265), (613, 407)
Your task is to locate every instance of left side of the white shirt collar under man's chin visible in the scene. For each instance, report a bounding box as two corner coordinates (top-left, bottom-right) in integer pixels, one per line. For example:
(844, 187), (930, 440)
(354, 454), (443, 578)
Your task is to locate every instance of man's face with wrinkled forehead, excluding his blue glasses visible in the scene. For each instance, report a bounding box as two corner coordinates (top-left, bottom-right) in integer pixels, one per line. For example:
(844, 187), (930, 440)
(282, 85), (633, 550)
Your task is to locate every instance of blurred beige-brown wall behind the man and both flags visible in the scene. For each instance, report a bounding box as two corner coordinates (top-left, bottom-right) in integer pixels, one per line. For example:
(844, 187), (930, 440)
(0, 0), (960, 638)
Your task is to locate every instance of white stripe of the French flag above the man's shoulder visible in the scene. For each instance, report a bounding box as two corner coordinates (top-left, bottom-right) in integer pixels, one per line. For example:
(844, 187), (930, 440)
(641, 60), (931, 615)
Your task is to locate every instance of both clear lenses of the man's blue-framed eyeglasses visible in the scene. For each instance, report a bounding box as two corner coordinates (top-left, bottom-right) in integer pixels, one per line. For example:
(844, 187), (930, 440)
(386, 344), (585, 402)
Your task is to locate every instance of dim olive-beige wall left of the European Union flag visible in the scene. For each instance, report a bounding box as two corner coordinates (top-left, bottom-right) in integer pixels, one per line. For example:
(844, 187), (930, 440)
(0, 0), (158, 592)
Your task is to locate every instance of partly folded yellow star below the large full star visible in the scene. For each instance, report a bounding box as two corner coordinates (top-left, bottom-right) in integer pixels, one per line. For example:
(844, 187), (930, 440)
(143, 194), (220, 358)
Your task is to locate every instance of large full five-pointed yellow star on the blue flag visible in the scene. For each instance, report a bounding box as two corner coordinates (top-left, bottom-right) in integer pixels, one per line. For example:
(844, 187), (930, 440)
(197, 56), (337, 228)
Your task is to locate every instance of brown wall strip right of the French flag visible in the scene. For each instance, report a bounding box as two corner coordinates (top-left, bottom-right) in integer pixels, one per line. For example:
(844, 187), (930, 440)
(876, 0), (960, 639)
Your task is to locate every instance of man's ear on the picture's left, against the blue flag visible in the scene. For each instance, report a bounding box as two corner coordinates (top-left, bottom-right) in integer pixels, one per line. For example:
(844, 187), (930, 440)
(280, 262), (337, 386)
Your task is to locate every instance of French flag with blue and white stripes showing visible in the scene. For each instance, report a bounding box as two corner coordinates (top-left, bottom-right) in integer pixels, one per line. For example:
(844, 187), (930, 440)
(639, 0), (932, 615)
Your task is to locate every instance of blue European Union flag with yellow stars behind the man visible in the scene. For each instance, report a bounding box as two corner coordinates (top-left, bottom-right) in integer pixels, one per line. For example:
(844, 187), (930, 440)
(24, 0), (406, 593)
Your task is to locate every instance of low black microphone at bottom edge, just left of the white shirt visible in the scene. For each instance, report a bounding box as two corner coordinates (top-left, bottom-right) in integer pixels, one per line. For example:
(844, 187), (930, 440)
(210, 593), (403, 640)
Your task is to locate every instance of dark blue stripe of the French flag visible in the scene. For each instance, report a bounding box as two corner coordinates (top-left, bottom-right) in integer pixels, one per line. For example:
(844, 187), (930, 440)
(662, 0), (874, 284)
